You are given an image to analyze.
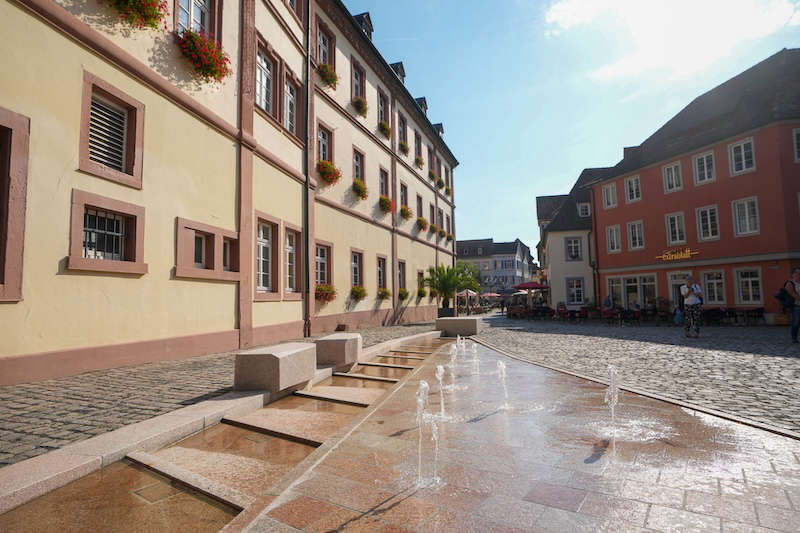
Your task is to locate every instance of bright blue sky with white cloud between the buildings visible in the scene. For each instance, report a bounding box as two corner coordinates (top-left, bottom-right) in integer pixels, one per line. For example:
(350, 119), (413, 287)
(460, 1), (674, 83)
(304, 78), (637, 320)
(344, 0), (800, 258)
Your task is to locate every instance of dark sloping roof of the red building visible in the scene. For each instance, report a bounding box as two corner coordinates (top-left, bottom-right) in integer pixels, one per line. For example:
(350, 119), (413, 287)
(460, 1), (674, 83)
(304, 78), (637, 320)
(594, 48), (800, 185)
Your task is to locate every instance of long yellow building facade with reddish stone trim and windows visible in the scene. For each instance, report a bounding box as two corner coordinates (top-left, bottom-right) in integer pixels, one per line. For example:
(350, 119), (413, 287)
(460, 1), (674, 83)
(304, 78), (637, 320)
(0, 0), (458, 384)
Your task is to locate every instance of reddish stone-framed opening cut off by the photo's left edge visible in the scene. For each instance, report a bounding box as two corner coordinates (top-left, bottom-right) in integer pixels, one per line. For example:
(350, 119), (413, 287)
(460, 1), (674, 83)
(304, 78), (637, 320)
(0, 107), (30, 302)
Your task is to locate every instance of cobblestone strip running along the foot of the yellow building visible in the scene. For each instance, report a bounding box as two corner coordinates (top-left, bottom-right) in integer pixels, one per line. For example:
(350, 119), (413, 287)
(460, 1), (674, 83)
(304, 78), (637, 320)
(0, 323), (433, 467)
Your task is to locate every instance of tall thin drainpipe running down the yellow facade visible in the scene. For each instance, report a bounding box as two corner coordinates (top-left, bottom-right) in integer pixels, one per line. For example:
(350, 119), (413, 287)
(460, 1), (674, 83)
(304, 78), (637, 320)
(303, 0), (314, 337)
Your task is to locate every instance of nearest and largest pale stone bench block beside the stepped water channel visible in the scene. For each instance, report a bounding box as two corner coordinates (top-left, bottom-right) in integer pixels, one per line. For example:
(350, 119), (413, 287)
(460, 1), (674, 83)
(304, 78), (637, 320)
(233, 342), (317, 395)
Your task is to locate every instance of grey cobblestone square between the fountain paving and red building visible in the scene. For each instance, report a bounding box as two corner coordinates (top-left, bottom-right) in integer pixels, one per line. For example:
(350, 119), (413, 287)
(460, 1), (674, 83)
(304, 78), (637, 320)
(478, 314), (800, 432)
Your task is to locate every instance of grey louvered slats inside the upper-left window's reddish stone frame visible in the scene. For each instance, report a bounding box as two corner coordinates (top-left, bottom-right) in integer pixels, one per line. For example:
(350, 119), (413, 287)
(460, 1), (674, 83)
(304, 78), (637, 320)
(89, 96), (128, 172)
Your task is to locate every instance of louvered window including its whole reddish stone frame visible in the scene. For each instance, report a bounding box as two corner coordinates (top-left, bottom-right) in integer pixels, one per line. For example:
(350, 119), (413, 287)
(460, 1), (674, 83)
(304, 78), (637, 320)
(78, 72), (144, 189)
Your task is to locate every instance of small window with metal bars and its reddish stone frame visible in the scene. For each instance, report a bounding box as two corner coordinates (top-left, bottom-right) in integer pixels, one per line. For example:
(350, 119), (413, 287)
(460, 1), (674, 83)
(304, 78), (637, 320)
(67, 189), (147, 274)
